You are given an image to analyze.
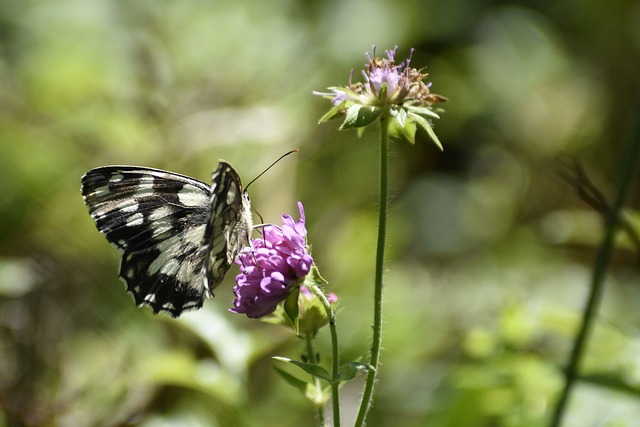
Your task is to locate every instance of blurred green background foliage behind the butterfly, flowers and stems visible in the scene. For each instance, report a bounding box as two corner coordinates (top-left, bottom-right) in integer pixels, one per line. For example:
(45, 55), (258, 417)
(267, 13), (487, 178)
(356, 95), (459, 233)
(0, 0), (640, 427)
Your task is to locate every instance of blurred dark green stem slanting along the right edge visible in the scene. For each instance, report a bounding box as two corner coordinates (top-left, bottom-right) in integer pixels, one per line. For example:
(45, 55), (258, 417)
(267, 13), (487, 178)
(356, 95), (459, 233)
(550, 105), (640, 427)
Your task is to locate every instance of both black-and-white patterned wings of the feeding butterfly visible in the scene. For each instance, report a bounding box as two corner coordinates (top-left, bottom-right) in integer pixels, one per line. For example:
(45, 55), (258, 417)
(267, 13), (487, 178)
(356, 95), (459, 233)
(82, 161), (253, 317)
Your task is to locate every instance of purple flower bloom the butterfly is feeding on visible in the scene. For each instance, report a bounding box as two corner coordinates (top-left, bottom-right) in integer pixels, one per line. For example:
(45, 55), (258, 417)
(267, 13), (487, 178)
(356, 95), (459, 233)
(229, 202), (313, 318)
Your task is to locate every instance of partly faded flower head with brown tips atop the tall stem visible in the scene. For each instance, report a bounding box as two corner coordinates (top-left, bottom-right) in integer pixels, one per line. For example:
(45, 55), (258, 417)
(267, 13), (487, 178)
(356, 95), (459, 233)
(314, 46), (447, 148)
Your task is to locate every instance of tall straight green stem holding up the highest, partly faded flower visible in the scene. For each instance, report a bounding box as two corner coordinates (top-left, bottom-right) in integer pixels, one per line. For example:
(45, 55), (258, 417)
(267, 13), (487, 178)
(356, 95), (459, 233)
(354, 111), (389, 427)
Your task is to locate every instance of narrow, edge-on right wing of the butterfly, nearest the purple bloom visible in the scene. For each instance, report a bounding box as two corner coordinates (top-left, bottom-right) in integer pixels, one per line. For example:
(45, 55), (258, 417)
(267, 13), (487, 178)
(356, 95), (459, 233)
(202, 161), (253, 292)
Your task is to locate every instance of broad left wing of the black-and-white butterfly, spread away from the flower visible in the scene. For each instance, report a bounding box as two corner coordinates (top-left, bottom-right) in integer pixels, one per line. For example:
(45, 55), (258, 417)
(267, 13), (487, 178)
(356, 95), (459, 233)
(82, 166), (211, 317)
